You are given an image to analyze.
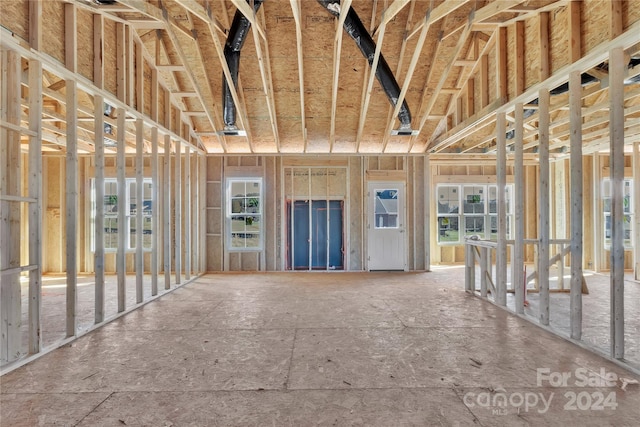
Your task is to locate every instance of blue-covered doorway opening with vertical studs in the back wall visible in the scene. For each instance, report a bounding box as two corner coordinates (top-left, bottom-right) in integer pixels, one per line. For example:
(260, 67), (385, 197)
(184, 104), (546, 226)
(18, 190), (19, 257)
(286, 200), (344, 270)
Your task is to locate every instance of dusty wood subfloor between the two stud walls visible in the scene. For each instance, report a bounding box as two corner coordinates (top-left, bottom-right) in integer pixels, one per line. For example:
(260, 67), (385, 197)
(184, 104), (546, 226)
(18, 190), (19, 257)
(0, 267), (640, 426)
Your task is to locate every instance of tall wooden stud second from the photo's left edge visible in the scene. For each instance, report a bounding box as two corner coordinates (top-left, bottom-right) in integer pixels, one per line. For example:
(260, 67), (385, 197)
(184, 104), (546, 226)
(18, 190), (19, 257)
(29, 59), (43, 354)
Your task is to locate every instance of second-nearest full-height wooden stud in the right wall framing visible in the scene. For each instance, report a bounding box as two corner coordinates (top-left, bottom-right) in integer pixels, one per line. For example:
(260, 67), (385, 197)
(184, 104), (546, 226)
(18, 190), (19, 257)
(569, 71), (584, 340)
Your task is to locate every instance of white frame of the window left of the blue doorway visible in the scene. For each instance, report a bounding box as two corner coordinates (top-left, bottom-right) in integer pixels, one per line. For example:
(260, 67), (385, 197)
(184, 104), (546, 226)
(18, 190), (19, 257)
(225, 177), (264, 252)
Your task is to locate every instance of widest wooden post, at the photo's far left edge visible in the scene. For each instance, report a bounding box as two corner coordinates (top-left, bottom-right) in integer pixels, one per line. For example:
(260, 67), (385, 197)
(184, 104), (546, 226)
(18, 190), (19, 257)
(0, 50), (22, 364)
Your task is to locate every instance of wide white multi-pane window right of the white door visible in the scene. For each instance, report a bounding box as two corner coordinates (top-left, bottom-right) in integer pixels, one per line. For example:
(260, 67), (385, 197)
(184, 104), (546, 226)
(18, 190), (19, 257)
(436, 184), (513, 244)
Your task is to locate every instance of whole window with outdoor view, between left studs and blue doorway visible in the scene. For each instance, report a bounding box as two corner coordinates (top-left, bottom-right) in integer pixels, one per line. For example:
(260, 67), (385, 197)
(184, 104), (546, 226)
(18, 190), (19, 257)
(226, 178), (263, 251)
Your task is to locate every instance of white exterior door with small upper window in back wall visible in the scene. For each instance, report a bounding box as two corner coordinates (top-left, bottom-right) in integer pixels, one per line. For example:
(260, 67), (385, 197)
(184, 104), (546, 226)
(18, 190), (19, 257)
(367, 182), (407, 270)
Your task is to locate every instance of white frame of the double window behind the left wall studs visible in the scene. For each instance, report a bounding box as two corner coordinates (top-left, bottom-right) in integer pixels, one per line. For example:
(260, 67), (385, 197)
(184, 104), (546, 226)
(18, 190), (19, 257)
(91, 178), (157, 253)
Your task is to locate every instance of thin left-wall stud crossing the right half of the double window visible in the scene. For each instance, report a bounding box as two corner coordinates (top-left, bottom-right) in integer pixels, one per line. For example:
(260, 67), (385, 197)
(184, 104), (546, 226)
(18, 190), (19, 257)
(136, 119), (144, 304)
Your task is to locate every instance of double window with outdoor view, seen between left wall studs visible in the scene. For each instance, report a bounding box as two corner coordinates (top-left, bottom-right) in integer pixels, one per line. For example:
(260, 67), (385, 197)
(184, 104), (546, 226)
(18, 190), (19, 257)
(91, 178), (153, 252)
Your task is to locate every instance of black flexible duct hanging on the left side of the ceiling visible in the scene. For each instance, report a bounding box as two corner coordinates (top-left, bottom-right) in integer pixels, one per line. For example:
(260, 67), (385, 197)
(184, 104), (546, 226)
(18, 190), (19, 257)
(222, 0), (263, 129)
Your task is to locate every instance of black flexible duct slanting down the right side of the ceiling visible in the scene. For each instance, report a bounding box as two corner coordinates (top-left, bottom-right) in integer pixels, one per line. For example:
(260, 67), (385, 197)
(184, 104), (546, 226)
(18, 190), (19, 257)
(318, 0), (411, 128)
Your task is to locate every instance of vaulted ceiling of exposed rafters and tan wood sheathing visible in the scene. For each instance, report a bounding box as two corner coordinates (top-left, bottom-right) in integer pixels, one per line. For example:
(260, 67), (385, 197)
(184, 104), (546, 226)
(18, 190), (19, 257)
(3, 0), (640, 154)
